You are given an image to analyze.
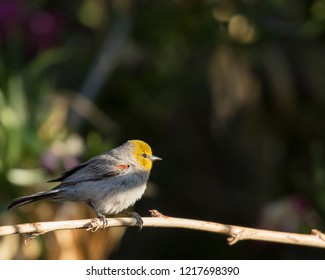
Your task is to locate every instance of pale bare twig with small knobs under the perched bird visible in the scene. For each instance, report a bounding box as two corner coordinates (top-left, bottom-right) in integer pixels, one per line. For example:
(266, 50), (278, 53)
(0, 210), (325, 248)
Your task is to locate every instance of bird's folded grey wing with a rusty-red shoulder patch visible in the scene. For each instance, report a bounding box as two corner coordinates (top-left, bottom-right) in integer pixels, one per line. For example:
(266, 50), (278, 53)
(48, 156), (129, 184)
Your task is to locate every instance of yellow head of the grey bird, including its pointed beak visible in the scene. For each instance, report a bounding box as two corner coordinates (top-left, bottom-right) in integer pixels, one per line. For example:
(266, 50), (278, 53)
(128, 140), (161, 171)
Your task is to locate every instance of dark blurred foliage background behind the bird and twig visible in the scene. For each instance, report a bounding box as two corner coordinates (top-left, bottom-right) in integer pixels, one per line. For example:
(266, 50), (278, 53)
(0, 0), (325, 259)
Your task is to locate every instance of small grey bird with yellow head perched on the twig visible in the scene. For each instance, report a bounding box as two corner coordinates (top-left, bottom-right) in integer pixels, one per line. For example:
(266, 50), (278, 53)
(7, 140), (161, 229)
